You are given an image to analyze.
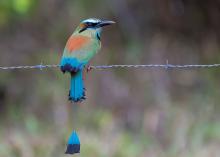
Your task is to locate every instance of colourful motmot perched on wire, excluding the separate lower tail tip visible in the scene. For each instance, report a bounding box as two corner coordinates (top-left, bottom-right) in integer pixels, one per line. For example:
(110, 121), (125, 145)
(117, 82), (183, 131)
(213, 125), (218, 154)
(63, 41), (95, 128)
(60, 18), (115, 102)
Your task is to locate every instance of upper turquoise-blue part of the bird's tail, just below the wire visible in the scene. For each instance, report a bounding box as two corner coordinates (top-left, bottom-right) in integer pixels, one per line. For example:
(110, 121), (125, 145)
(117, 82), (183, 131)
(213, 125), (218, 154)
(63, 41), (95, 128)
(69, 70), (85, 102)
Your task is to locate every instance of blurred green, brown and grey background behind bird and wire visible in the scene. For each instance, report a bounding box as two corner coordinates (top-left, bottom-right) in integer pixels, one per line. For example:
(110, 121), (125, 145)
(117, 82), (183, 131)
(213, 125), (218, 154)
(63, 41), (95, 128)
(0, 0), (220, 157)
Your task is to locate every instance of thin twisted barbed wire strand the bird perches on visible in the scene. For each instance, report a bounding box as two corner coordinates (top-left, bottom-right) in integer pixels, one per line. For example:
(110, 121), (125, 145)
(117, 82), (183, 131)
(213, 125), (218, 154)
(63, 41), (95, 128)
(0, 60), (220, 70)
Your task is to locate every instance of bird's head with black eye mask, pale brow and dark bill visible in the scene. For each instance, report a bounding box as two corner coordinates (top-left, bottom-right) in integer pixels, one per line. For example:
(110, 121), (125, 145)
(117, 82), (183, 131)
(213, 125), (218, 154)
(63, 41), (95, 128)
(76, 18), (115, 39)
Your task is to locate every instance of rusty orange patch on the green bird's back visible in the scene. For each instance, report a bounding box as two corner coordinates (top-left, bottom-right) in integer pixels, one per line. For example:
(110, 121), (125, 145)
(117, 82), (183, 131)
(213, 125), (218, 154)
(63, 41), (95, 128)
(66, 36), (90, 52)
